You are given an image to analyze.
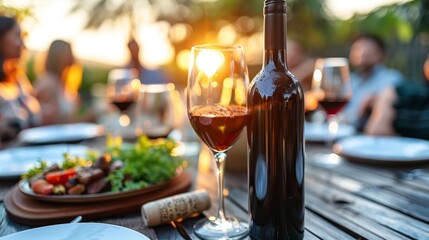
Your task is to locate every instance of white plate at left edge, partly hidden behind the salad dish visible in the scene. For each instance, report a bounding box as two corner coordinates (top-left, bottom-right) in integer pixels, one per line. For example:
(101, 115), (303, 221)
(0, 144), (88, 178)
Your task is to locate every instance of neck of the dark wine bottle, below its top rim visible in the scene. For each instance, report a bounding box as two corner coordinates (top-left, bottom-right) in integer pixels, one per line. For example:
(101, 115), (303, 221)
(264, 5), (287, 68)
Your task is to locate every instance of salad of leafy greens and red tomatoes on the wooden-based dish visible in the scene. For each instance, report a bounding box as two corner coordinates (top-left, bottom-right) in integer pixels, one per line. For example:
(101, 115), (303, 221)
(22, 136), (182, 195)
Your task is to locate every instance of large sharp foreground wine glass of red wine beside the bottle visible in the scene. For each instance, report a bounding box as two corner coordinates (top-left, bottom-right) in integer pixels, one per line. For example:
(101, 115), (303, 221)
(187, 45), (249, 239)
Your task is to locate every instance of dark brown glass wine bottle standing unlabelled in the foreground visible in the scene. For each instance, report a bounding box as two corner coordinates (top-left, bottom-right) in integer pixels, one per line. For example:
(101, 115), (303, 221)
(247, 0), (305, 240)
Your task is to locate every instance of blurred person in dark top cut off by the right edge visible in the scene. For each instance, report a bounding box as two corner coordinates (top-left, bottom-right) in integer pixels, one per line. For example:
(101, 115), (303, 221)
(365, 53), (429, 140)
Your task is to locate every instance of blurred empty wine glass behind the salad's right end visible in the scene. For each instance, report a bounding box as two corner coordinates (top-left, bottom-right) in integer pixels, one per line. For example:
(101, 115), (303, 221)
(136, 83), (176, 139)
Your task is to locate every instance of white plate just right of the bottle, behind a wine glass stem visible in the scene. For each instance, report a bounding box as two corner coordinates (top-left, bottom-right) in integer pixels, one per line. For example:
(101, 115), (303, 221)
(304, 122), (356, 142)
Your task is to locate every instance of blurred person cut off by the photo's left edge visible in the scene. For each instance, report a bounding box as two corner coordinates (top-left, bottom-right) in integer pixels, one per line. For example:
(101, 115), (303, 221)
(0, 16), (40, 141)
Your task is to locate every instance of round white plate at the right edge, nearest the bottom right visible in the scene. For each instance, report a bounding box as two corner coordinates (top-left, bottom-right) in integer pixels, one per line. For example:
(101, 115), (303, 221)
(333, 136), (429, 164)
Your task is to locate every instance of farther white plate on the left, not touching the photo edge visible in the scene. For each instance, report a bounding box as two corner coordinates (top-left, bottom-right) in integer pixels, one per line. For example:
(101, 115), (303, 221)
(19, 123), (104, 144)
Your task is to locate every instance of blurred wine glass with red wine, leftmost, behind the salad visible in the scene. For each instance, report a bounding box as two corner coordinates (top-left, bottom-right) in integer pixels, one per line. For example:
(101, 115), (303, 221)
(106, 68), (140, 130)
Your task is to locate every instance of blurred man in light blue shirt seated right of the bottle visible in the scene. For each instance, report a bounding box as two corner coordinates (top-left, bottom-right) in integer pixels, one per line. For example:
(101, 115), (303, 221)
(342, 34), (403, 126)
